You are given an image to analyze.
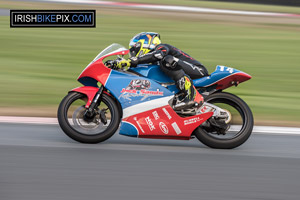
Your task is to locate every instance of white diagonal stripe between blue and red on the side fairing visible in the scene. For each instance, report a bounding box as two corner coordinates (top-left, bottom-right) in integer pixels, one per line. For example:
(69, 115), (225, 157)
(123, 95), (173, 119)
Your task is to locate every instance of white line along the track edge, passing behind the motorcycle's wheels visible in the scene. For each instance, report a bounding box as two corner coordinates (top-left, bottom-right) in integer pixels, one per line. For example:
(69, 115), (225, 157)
(0, 116), (300, 135)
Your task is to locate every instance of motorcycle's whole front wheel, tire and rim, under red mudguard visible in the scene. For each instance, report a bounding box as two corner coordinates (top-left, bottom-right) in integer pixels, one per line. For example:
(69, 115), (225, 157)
(57, 92), (121, 144)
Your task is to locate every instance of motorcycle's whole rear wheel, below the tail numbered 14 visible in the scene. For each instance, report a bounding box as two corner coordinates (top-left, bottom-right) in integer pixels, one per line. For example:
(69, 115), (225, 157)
(194, 92), (253, 149)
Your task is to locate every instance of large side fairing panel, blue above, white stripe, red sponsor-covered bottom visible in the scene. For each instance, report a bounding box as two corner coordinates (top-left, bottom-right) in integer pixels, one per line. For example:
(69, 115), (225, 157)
(106, 70), (212, 140)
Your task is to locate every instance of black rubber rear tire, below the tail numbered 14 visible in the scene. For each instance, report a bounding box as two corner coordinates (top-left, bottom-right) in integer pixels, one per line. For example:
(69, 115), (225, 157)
(194, 92), (254, 149)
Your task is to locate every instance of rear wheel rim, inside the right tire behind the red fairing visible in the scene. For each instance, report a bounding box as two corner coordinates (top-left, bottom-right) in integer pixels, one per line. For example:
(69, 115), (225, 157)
(204, 98), (247, 140)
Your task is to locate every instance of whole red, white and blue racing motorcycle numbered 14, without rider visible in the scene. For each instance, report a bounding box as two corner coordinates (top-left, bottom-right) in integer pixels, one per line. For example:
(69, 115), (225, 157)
(58, 44), (253, 149)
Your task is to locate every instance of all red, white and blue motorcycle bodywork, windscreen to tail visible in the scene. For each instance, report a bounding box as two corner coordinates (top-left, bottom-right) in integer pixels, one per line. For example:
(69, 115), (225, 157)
(72, 45), (251, 139)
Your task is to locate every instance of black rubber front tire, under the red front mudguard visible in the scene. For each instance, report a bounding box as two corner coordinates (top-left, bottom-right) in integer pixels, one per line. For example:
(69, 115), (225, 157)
(57, 92), (121, 144)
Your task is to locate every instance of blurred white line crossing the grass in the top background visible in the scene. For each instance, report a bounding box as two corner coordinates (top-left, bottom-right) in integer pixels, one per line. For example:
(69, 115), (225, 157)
(45, 0), (300, 17)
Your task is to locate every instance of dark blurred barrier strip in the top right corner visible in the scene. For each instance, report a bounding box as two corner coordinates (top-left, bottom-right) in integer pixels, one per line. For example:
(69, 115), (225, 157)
(206, 0), (300, 6)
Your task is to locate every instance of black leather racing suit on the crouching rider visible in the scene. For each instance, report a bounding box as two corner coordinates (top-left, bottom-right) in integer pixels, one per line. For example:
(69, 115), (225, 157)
(130, 44), (209, 82)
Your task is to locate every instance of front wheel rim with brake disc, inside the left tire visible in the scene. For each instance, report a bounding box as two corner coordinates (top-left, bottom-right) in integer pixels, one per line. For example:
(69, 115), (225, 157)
(66, 95), (112, 136)
